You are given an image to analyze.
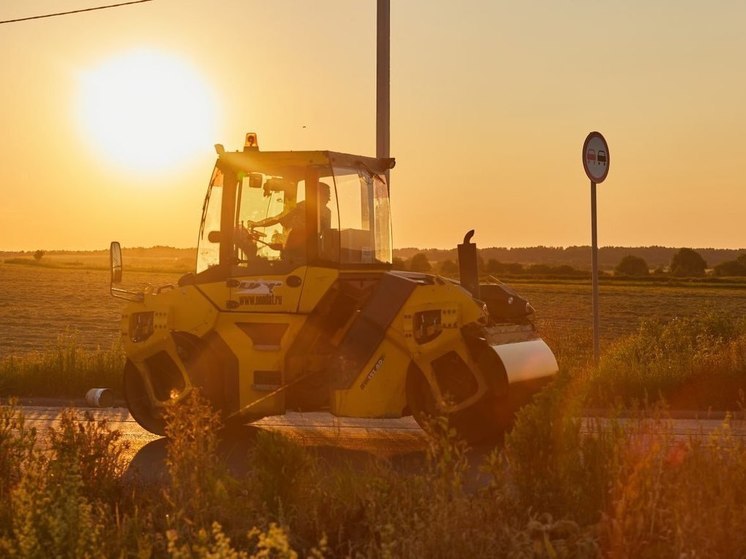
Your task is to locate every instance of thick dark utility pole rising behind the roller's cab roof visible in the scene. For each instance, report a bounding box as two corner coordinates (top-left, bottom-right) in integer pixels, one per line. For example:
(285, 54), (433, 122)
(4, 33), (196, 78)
(376, 0), (391, 184)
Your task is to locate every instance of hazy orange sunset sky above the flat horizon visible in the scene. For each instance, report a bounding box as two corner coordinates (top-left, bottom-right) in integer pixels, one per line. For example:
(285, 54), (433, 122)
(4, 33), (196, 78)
(0, 0), (746, 250)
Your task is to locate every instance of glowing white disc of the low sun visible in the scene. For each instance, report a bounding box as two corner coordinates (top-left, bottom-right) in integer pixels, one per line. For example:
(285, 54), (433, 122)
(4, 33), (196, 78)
(78, 49), (215, 172)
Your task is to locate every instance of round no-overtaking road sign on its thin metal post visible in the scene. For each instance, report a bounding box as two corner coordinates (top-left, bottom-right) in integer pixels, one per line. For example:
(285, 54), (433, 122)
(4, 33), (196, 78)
(583, 132), (610, 365)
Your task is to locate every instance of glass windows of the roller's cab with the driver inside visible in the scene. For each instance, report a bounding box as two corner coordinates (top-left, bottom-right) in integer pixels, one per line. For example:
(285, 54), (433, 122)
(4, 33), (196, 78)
(197, 158), (392, 275)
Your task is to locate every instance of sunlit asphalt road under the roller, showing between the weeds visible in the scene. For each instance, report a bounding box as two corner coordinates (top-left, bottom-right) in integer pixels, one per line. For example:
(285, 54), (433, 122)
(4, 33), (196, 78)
(10, 406), (746, 486)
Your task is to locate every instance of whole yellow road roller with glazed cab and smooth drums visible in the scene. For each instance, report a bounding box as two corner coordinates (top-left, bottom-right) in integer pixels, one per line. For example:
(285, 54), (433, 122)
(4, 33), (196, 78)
(112, 134), (557, 442)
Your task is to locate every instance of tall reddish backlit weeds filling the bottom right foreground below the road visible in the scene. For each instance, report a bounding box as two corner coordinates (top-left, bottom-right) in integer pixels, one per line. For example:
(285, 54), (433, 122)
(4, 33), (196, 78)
(500, 382), (746, 558)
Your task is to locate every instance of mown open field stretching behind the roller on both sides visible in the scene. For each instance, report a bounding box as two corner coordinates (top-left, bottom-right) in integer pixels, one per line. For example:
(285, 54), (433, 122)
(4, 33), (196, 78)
(0, 253), (746, 356)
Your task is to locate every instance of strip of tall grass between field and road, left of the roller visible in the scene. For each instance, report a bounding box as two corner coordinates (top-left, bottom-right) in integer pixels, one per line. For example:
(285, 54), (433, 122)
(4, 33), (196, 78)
(0, 334), (124, 398)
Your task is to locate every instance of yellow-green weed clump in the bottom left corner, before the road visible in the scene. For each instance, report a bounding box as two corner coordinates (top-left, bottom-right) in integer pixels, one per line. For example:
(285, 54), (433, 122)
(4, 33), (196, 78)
(0, 404), (122, 558)
